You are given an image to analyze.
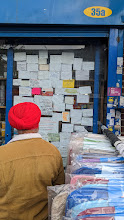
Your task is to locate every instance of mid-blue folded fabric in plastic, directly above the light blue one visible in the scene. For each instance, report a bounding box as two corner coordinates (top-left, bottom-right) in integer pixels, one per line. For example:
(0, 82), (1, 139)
(66, 184), (124, 210)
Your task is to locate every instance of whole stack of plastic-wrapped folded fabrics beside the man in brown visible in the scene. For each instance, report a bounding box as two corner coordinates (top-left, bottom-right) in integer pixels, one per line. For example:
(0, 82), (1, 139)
(48, 133), (124, 220)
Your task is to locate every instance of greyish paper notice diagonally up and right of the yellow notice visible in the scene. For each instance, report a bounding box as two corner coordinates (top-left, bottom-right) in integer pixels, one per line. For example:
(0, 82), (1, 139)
(75, 70), (89, 80)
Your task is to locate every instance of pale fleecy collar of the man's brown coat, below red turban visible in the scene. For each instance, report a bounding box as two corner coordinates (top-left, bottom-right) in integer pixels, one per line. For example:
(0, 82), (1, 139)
(8, 133), (42, 143)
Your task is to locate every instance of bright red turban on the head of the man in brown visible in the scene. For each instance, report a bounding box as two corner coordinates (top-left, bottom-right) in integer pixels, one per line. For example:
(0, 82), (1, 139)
(8, 102), (41, 130)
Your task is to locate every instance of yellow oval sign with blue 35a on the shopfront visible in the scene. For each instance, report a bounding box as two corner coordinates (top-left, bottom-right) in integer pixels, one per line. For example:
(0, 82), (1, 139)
(84, 6), (112, 18)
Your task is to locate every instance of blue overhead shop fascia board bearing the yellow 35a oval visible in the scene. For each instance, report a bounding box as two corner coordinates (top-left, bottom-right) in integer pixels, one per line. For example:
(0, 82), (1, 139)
(0, 0), (124, 25)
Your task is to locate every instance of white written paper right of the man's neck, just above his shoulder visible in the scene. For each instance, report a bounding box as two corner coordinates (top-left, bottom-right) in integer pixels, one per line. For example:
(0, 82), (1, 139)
(39, 117), (58, 134)
